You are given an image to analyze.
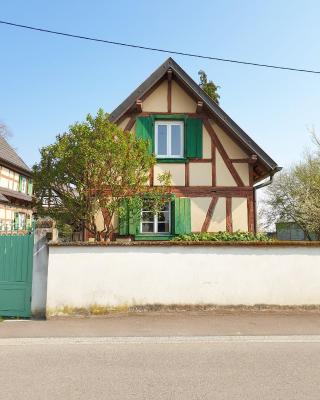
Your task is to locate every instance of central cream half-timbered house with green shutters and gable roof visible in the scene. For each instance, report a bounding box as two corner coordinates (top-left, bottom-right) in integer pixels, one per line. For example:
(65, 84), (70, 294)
(110, 58), (280, 239)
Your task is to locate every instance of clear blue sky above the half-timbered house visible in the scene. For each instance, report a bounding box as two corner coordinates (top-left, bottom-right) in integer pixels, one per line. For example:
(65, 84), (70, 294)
(0, 0), (320, 166)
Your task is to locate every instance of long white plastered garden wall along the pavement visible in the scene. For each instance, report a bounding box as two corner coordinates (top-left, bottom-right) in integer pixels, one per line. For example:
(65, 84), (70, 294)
(47, 245), (320, 314)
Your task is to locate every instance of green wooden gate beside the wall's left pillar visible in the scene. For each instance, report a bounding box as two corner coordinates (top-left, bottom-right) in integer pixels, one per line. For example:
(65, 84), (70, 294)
(0, 229), (34, 317)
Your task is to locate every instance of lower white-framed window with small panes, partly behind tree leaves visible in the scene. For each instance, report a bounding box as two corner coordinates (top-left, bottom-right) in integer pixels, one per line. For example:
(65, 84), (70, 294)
(140, 202), (171, 234)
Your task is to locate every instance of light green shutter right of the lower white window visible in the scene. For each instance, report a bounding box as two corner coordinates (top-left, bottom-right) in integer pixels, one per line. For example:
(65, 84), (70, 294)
(172, 197), (191, 235)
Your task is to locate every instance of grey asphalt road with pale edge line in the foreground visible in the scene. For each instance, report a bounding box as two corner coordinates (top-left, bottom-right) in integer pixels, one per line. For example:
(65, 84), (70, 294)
(0, 336), (320, 400)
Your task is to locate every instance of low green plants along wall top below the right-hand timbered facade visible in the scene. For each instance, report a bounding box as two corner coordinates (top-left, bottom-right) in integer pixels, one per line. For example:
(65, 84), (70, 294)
(174, 231), (272, 242)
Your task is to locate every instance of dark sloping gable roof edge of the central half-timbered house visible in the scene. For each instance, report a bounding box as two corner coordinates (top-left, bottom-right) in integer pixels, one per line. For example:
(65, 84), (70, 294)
(110, 57), (280, 172)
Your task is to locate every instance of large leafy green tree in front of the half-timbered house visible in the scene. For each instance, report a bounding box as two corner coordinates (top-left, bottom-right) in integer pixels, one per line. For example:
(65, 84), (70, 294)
(33, 109), (170, 240)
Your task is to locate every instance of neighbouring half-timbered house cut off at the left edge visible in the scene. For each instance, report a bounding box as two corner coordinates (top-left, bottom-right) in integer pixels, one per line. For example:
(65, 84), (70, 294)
(0, 137), (32, 232)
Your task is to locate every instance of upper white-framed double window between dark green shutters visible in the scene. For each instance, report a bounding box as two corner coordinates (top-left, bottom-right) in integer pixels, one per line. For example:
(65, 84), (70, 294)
(155, 121), (184, 158)
